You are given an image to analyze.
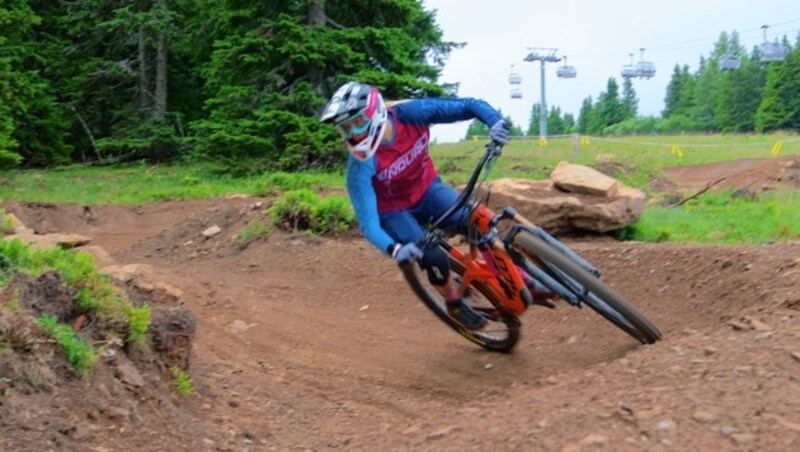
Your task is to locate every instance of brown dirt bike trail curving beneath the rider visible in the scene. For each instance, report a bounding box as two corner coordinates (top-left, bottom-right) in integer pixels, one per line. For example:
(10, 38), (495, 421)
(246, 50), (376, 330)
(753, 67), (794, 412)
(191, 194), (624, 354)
(0, 156), (800, 451)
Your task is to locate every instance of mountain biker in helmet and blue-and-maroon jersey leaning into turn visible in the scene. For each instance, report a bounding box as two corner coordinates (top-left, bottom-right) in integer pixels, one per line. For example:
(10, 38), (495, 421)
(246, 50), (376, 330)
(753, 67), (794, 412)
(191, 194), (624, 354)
(320, 82), (540, 330)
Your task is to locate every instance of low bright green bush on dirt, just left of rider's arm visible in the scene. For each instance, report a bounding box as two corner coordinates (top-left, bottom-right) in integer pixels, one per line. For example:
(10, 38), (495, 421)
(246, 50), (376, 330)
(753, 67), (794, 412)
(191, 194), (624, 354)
(269, 189), (355, 234)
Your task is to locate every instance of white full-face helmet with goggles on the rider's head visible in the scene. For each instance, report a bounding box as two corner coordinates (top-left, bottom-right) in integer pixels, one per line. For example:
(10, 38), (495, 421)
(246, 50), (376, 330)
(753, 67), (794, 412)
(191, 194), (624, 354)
(319, 82), (386, 160)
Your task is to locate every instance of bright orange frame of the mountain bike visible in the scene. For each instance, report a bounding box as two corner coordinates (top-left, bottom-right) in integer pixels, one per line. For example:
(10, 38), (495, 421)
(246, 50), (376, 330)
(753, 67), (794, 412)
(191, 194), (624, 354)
(449, 204), (527, 315)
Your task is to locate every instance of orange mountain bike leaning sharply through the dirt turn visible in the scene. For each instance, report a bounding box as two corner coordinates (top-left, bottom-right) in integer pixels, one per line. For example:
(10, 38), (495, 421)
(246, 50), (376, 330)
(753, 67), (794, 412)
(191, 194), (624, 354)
(400, 141), (661, 352)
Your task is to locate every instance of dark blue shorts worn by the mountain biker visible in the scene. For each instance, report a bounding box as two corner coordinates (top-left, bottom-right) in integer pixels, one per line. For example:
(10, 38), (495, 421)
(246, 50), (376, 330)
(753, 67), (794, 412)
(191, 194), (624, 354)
(380, 177), (468, 247)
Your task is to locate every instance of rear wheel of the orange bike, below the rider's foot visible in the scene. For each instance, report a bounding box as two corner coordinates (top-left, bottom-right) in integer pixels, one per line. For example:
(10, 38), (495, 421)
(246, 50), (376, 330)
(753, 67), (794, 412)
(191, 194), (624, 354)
(400, 251), (520, 353)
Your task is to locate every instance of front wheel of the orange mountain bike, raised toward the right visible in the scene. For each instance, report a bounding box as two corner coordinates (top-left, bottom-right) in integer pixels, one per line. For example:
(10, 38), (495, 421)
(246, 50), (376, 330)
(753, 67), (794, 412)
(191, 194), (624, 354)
(514, 231), (661, 344)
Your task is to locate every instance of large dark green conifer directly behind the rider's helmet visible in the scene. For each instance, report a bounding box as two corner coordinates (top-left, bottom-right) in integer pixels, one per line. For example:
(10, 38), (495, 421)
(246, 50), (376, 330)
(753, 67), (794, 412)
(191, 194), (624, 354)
(192, 0), (457, 170)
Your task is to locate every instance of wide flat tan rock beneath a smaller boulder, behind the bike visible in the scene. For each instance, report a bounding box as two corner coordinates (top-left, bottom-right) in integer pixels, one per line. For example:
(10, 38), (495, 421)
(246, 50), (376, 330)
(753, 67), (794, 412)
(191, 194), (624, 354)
(482, 179), (644, 234)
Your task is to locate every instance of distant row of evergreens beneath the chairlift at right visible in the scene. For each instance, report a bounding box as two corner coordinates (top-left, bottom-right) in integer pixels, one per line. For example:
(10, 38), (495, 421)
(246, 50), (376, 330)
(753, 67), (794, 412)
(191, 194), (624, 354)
(467, 32), (800, 136)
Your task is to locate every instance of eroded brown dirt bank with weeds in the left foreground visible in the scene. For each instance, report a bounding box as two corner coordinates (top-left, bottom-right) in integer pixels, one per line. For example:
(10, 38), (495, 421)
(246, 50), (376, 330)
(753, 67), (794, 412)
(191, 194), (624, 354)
(0, 272), (195, 450)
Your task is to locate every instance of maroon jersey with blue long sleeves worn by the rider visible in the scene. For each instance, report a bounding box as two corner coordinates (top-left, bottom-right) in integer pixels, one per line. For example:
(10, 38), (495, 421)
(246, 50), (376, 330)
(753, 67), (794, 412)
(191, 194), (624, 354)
(347, 98), (503, 253)
